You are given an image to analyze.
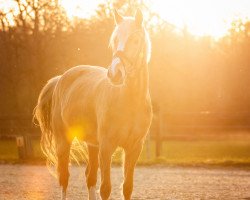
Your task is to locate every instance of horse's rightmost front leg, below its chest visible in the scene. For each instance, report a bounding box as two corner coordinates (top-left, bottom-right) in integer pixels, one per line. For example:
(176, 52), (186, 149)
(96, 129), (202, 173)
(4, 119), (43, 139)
(123, 141), (143, 200)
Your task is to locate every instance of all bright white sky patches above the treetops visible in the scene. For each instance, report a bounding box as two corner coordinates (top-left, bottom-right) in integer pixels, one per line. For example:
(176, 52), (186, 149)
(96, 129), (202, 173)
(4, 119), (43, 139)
(0, 0), (250, 38)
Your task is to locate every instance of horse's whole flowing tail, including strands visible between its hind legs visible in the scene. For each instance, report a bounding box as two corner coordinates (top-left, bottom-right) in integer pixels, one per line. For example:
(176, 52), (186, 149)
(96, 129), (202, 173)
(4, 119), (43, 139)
(34, 76), (88, 172)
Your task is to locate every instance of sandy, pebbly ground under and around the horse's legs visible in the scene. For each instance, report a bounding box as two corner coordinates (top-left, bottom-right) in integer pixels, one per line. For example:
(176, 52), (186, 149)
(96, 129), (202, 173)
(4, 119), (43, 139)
(0, 165), (250, 200)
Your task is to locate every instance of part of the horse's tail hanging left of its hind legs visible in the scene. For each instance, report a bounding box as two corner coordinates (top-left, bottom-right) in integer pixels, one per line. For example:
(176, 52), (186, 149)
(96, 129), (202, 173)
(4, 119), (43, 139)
(34, 76), (60, 168)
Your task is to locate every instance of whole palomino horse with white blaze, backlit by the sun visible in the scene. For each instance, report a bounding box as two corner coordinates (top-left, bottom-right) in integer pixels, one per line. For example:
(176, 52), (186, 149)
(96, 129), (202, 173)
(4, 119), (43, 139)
(35, 10), (152, 200)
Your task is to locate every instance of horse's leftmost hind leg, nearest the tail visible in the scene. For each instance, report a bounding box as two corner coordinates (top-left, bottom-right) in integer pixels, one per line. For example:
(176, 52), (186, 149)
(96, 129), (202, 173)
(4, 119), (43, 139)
(57, 136), (70, 200)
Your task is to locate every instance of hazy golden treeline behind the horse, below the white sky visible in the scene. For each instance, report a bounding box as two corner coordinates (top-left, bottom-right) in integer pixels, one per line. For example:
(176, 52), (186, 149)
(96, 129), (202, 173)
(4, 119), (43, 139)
(0, 0), (250, 134)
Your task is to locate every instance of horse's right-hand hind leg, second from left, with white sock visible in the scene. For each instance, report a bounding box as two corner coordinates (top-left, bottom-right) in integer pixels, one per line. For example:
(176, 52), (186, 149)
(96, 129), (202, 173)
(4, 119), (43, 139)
(85, 145), (99, 200)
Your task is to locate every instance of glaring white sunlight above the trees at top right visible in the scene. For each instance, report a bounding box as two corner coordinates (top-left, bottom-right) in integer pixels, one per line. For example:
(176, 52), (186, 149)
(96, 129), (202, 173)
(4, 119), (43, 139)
(149, 0), (250, 38)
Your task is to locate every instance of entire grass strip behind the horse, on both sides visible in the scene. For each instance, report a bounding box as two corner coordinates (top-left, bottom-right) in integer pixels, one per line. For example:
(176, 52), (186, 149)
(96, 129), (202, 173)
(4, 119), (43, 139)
(0, 139), (250, 166)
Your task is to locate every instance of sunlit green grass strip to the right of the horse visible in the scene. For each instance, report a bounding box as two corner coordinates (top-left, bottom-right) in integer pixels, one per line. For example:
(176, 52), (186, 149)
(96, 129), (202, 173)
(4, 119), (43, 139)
(141, 140), (250, 165)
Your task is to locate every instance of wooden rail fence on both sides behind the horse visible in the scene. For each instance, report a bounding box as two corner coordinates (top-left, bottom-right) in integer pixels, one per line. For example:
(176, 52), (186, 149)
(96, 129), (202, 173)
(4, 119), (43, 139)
(0, 110), (250, 159)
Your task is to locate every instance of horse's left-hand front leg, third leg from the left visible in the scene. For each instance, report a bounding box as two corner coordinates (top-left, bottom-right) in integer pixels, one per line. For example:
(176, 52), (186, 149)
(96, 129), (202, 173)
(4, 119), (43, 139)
(99, 139), (115, 200)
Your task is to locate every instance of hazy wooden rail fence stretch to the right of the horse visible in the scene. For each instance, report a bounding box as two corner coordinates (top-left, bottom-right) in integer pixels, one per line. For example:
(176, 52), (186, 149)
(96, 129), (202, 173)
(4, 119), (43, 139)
(150, 109), (250, 157)
